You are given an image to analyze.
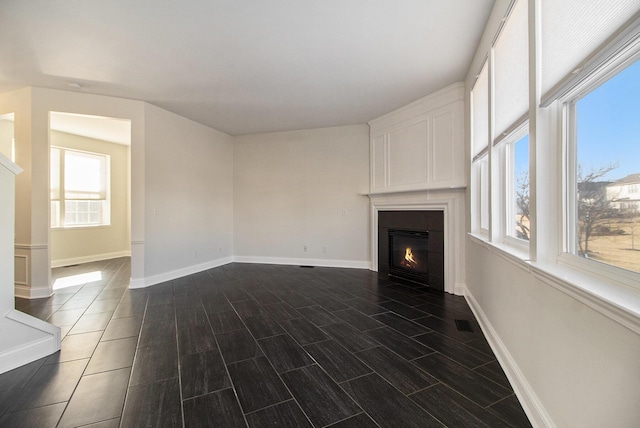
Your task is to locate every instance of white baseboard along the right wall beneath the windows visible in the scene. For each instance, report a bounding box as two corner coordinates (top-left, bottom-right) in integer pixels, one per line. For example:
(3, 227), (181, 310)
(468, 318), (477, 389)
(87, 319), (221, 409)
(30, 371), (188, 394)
(464, 288), (556, 428)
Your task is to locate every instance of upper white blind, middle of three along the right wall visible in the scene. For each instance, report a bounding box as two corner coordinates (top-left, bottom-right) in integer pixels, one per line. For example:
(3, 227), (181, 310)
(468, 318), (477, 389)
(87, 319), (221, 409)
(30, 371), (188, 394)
(493, 0), (529, 140)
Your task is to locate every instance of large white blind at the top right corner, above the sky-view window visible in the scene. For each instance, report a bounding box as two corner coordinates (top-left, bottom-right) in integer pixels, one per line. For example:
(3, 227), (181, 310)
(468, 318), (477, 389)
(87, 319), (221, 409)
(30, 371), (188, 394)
(540, 0), (640, 105)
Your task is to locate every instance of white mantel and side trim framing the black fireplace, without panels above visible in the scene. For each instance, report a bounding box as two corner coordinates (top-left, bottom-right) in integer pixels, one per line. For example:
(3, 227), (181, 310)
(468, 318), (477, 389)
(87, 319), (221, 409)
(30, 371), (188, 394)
(369, 187), (466, 296)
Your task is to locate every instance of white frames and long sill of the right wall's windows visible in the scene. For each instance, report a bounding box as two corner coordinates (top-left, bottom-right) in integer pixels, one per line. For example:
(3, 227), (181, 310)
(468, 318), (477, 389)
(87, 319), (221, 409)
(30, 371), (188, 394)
(467, 2), (640, 334)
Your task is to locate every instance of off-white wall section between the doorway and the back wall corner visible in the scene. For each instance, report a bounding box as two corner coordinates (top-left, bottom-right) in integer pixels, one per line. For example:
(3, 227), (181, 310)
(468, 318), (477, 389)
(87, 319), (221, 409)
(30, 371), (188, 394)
(143, 104), (233, 286)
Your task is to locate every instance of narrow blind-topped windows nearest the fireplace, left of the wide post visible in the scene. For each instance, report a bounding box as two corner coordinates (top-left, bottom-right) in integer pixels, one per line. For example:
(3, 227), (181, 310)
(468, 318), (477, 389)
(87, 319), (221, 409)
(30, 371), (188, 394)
(471, 0), (531, 247)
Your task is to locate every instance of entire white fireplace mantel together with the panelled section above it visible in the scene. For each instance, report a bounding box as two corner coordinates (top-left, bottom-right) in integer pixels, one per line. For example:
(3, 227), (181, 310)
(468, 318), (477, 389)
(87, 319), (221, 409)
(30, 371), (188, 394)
(367, 83), (467, 295)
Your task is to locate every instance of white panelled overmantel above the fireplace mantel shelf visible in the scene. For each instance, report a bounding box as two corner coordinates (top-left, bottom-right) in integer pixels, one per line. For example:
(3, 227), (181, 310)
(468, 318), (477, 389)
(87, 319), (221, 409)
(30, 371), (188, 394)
(369, 83), (466, 193)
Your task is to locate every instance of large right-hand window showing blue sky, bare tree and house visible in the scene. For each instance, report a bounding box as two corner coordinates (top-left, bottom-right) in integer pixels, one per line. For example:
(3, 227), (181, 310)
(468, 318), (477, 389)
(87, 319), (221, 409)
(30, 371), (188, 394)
(565, 55), (640, 272)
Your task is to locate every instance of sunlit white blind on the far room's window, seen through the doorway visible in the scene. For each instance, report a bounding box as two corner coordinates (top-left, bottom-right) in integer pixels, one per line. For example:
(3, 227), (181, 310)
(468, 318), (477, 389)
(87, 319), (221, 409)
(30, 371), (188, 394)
(64, 150), (108, 200)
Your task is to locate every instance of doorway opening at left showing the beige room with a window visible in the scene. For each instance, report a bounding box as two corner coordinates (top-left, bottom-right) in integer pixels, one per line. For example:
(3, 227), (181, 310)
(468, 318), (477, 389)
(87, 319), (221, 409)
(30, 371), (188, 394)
(49, 111), (131, 282)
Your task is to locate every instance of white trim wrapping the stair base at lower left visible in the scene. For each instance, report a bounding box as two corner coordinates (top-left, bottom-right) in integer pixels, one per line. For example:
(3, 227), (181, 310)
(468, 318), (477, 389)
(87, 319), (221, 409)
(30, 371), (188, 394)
(0, 309), (61, 373)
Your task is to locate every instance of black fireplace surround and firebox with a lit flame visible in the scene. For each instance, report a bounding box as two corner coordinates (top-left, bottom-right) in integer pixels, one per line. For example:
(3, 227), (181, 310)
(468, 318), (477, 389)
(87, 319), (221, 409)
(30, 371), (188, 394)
(378, 211), (444, 291)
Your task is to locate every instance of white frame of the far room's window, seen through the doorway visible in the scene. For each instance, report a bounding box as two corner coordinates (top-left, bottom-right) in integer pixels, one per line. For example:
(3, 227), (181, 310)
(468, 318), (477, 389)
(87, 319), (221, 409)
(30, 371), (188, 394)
(49, 145), (111, 230)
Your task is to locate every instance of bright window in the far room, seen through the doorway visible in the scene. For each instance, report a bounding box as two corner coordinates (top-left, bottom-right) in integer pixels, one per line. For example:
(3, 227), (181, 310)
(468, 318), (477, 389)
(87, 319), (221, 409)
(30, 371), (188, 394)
(50, 147), (110, 227)
